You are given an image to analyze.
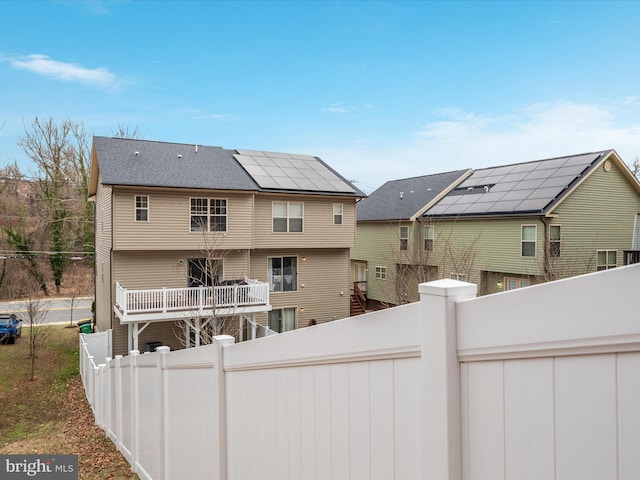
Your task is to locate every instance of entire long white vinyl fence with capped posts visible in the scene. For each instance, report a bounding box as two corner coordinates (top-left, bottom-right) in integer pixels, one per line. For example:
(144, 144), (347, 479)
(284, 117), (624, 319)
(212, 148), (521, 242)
(81, 265), (640, 480)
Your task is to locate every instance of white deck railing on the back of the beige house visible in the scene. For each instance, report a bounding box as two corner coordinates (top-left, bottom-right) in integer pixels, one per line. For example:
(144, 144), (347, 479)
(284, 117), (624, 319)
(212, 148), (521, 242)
(116, 279), (269, 315)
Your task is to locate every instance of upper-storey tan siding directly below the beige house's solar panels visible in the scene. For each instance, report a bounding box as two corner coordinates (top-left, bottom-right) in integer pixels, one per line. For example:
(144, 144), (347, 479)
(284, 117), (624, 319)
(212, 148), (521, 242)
(255, 195), (355, 248)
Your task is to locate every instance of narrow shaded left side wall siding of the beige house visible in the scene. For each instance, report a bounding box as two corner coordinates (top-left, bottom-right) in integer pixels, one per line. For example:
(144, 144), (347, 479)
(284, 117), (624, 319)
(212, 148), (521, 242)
(95, 176), (113, 332)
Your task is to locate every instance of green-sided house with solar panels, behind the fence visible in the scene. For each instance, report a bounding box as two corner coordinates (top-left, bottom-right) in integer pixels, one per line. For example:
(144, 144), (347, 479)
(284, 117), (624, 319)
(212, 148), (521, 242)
(351, 150), (640, 307)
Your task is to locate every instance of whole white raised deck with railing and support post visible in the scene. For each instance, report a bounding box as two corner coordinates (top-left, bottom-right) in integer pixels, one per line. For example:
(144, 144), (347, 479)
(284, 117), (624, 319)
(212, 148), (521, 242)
(113, 278), (271, 351)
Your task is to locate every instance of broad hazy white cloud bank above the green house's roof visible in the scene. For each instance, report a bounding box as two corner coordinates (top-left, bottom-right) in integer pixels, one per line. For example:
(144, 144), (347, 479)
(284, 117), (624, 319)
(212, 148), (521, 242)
(316, 101), (640, 193)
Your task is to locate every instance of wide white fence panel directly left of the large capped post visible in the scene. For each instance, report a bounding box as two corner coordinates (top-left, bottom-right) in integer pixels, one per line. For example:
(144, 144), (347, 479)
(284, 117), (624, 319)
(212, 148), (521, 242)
(225, 304), (421, 478)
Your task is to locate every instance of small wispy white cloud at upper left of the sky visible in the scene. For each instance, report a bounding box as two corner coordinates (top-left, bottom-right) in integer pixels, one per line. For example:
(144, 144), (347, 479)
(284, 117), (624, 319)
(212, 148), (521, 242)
(5, 54), (117, 88)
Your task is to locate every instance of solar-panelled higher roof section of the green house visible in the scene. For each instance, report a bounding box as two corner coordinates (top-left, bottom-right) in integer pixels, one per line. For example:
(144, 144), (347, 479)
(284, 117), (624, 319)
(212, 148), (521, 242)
(424, 150), (637, 217)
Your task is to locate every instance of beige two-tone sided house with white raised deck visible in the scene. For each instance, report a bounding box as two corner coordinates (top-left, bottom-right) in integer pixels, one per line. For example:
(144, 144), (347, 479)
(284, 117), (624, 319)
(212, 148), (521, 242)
(89, 137), (364, 355)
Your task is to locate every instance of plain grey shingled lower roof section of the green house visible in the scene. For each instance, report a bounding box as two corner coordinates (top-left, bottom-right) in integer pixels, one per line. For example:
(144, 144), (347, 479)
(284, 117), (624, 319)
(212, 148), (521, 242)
(357, 170), (472, 222)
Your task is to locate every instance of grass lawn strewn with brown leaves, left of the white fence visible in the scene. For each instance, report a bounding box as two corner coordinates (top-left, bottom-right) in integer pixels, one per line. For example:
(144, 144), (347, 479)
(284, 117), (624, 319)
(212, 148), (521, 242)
(0, 325), (138, 480)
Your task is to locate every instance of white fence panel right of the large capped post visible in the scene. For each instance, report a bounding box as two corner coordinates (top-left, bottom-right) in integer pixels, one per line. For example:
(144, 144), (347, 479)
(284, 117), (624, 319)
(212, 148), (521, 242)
(457, 265), (640, 479)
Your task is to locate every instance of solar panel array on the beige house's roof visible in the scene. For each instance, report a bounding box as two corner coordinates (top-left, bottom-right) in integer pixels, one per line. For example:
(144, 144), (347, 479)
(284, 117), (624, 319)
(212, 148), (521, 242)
(234, 150), (355, 193)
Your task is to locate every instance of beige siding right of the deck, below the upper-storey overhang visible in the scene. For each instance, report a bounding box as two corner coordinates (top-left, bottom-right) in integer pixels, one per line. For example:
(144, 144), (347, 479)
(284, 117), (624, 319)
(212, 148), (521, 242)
(250, 249), (349, 328)
